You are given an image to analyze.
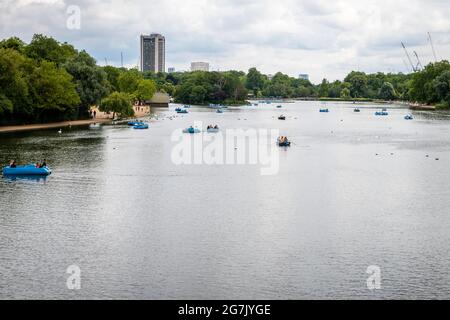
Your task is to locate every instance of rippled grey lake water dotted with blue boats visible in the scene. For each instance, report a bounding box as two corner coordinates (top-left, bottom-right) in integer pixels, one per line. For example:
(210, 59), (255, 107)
(0, 102), (450, 299)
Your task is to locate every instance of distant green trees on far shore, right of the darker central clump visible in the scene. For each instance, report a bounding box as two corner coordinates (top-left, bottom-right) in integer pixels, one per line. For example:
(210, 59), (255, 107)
(246, 61), (450, 108)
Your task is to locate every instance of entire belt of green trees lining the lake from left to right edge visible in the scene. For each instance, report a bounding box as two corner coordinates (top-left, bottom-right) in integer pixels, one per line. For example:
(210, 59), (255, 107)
(0, 34), (450, 125)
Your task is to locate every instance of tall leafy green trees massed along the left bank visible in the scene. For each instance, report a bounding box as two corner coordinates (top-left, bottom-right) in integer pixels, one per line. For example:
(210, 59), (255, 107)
(0, 34), (157, 125)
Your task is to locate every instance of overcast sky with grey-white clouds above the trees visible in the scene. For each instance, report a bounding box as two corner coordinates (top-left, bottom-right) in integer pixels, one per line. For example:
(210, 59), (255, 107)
(0, 0), (450, 82)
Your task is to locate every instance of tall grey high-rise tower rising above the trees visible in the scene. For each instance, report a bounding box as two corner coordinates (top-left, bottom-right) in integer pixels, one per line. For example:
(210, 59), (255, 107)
(141, 33), (166, 72)
